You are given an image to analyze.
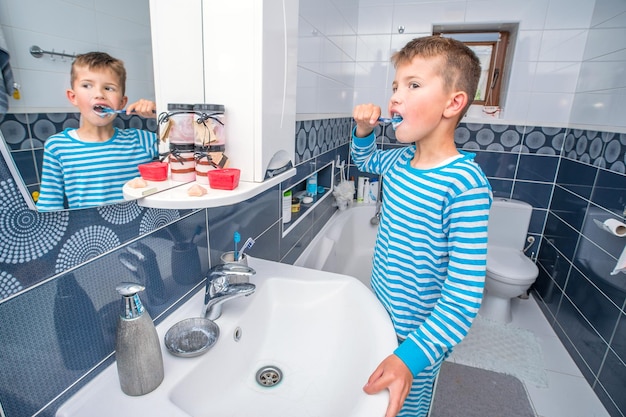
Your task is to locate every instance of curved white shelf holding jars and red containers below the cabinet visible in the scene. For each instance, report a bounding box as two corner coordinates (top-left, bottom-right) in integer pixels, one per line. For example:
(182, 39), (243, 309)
(125, 168), (297, 210)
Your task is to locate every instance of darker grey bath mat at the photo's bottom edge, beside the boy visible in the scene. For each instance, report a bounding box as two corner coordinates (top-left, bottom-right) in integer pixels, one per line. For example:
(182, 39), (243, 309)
(430, 361), (535, 417)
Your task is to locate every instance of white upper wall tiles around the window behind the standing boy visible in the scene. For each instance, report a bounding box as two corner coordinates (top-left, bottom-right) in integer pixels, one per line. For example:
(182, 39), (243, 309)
(298, 0), (626, 131)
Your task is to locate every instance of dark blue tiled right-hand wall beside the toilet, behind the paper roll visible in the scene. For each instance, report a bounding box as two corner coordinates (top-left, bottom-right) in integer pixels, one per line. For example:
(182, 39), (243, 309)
(534, 143), (626, 416)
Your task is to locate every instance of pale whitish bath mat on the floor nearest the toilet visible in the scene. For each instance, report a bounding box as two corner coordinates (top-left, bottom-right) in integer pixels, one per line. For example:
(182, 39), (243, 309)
(450, 316), (548, 388)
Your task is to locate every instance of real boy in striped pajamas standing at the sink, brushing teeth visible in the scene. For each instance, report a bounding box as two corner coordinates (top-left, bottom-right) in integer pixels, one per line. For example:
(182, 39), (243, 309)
(352, 36), (492, 417)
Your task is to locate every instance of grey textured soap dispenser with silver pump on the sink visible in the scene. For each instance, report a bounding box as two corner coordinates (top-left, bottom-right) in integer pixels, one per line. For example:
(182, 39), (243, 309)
(115, 282), (164, 396)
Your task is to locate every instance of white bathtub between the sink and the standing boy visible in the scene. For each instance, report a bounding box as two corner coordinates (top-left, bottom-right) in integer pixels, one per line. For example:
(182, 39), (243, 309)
(294, 204), (378, 287)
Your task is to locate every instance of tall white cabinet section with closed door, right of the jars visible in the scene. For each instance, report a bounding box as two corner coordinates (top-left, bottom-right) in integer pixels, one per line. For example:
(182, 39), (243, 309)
(202, 0), (298, 182)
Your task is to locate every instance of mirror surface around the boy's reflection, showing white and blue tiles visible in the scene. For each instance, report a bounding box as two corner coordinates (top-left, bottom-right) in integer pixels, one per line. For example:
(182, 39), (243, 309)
(0, 0), (171, 209)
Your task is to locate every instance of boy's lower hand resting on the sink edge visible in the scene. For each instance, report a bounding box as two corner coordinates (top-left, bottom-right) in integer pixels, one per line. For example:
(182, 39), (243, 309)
(363, 355), (413, 417)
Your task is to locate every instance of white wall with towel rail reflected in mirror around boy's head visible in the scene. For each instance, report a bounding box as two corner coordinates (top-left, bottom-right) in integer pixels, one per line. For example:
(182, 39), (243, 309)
(0, 0), (154, 113)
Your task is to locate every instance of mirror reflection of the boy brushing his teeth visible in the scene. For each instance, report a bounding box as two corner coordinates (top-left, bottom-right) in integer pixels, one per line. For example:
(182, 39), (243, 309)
(37, 52), (158, 211)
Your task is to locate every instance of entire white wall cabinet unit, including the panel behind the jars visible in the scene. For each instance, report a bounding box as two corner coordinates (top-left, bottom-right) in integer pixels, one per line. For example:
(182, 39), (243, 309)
(149, 0), (298, 208)
